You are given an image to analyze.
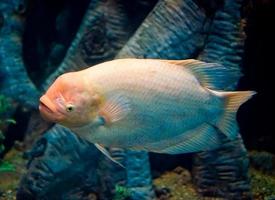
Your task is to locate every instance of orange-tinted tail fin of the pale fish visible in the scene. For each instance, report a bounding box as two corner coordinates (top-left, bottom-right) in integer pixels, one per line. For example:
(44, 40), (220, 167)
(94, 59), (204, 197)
(214, 91), (256, 139)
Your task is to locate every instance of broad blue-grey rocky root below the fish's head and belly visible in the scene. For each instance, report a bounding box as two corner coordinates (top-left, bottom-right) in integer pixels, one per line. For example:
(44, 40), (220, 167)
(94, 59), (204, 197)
(17, 125), (100, 200)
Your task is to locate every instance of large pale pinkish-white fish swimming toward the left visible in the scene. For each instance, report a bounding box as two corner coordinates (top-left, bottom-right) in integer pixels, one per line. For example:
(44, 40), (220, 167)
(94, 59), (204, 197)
(39, 59), (255, 165)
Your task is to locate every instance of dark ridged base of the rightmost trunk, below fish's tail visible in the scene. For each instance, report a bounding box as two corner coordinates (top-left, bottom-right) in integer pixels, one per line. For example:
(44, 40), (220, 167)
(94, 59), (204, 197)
(193, 136), (251, 199)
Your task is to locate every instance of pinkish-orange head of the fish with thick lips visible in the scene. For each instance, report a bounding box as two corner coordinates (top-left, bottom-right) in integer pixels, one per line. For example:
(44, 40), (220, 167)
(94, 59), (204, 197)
(39, 72), (100, 128)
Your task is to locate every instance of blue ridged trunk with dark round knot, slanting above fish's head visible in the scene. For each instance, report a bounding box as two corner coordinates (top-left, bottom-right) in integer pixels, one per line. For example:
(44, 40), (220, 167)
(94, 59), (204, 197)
(43, 0), (154, 90)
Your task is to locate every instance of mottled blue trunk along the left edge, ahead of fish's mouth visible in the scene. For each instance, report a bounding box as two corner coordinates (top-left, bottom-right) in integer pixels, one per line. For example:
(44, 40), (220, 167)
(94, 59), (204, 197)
(0, 1), (39, 108)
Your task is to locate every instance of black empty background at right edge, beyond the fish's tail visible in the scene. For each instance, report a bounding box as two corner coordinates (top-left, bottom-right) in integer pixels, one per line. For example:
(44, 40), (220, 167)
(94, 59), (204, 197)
(238, 0), (275, 153)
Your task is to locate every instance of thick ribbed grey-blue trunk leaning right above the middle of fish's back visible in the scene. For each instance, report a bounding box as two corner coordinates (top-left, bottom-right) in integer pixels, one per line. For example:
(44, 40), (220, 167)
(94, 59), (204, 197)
(117, 0), (210, 59)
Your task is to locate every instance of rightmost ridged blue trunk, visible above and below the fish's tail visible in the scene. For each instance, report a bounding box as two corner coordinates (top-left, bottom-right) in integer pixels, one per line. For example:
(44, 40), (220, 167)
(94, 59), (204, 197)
(193, 0), (251, 199)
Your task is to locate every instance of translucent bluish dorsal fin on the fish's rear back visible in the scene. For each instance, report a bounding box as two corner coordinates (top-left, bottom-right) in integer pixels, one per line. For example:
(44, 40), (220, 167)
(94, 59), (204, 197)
(160, 59), (235, 89)
